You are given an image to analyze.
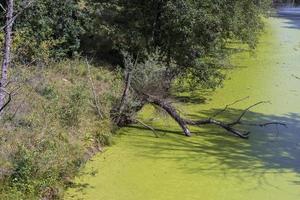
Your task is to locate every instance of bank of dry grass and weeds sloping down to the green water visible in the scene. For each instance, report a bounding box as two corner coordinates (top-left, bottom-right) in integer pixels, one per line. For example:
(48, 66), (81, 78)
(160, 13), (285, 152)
(0, 60), (120, 199)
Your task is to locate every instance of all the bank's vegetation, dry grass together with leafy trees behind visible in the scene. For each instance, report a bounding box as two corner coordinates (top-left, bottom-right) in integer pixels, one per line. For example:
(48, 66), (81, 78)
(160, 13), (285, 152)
(0, 0), (271, 199)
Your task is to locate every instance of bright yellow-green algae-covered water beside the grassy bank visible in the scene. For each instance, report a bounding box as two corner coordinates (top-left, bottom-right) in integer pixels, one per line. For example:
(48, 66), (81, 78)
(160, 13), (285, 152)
(65, 18), (300, 200)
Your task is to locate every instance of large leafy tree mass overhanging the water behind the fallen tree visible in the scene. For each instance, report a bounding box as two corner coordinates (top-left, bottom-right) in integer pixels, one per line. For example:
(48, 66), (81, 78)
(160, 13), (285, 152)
(91, 0), (271, 87)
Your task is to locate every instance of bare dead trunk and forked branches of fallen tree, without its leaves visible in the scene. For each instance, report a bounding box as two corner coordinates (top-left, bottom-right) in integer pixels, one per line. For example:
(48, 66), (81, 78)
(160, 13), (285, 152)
(116, 53), (283, 139)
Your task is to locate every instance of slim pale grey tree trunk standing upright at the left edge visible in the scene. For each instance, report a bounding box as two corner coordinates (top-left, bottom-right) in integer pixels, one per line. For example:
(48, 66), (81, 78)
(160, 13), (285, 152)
(0, 0), (14, 111)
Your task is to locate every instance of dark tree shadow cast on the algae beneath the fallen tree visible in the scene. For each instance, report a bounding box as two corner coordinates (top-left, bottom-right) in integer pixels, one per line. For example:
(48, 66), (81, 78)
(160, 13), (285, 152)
(125, 109), (300, 185)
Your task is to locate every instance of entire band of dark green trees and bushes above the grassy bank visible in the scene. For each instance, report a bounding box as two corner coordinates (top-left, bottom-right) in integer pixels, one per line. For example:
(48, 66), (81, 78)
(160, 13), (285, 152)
(2, 0), (272, 88)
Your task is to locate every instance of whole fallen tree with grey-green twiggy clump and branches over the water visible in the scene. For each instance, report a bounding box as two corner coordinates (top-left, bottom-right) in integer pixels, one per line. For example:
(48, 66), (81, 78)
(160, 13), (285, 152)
(112, 56), (287, 139)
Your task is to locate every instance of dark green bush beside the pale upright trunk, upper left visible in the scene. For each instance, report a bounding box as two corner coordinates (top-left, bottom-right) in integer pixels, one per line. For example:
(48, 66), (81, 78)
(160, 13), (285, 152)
(10, 0), (85, 62)
